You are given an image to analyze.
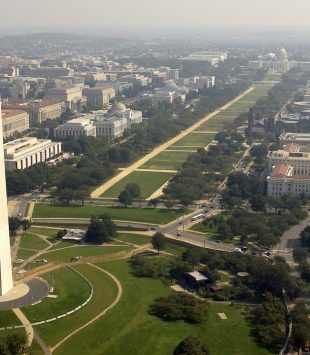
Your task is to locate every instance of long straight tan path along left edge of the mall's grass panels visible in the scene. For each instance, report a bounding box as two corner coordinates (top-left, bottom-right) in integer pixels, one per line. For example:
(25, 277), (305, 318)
(90, 87), (254, 197)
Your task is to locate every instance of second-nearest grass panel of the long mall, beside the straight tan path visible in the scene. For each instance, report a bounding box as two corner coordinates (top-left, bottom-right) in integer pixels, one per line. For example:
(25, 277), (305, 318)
(141, 151), (194, 170)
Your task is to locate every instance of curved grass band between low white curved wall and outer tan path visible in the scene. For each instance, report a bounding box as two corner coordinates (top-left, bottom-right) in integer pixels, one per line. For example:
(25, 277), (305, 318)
(35, 265), (117, 348)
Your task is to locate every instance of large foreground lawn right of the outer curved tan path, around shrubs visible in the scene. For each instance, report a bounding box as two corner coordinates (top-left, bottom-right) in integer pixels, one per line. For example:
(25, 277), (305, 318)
(54, 261), (269, 355)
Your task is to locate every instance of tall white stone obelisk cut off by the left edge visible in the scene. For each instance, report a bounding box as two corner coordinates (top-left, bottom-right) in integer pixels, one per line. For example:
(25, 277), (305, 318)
(0, 99), (13, 296)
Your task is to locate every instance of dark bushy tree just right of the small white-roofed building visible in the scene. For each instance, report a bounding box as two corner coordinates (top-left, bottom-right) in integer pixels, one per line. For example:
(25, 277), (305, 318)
(85, 214), (117, 244)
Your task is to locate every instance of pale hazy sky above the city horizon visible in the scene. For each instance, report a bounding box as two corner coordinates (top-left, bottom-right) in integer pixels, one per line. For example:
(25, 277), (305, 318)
(0, 0), (310, 30)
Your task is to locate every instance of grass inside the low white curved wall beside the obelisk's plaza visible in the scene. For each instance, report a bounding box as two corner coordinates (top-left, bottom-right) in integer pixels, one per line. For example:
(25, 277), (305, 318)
(22, 268), (90, 322)
